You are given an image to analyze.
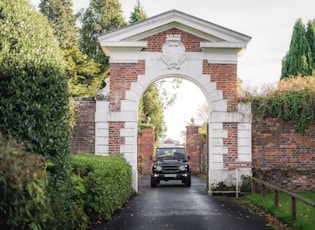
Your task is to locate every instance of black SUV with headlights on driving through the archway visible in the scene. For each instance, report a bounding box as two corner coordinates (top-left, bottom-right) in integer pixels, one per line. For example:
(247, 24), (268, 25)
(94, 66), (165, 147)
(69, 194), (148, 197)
(151, 147), (191, 187)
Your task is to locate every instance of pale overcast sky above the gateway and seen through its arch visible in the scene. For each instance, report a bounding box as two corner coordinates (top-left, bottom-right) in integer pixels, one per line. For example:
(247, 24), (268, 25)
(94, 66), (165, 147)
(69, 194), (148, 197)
(31, 0), (315, 141)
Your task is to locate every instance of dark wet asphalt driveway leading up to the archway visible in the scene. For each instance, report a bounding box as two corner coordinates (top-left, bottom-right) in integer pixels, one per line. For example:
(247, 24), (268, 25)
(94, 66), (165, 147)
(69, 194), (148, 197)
(92, 176), (272, 230)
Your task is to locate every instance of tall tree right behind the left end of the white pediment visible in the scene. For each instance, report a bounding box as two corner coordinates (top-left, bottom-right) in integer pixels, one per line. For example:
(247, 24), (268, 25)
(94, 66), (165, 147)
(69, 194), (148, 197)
(78, 0), (126, 74)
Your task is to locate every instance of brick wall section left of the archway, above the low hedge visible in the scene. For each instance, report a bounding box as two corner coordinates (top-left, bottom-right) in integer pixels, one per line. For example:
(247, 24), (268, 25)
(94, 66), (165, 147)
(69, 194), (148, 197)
(70, 98), (96, 153)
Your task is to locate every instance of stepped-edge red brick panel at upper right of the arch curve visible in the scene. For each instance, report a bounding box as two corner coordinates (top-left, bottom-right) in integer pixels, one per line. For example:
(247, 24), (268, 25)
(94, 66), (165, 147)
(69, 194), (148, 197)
(203, 60), (238, 112)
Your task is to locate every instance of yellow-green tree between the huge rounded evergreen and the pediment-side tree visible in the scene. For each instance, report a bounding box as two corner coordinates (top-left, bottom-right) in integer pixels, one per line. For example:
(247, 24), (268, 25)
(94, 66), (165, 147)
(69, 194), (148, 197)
(39, 0), (99, 97)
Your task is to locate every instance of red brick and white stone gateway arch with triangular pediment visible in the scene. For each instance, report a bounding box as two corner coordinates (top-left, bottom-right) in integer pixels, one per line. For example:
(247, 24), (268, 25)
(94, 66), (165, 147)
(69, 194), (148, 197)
(95, 10), (251, 192)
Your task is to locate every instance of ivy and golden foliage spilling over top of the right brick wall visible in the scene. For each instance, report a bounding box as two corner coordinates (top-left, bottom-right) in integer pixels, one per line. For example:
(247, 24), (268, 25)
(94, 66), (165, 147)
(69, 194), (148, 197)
(248, 76), (315, 133)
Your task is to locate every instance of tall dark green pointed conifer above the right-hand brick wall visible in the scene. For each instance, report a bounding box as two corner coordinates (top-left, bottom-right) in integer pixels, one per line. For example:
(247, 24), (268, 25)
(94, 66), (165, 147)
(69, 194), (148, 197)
(281, 19), (312, 79)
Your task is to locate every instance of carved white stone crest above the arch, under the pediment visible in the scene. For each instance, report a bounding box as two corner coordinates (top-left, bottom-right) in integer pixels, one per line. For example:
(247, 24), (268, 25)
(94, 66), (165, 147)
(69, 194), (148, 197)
(162, 34), (186, 69)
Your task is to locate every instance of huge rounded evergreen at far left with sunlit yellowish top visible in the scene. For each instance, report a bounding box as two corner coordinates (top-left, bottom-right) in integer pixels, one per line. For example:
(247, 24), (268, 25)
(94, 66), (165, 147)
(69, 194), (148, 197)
(0, 0), (72, 229)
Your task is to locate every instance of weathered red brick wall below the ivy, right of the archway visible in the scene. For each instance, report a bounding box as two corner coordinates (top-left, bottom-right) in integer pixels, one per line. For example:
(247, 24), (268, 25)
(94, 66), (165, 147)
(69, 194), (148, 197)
(252, 116), (315, 192)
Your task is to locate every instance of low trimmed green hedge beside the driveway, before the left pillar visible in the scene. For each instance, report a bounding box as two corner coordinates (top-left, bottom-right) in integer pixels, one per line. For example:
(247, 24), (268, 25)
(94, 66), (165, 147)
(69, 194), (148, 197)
(71, 154), (134, 229)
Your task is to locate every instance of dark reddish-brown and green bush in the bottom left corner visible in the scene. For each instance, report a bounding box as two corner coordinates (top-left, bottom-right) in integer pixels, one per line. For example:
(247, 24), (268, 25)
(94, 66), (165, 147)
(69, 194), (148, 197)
(0, 136), (51, 229)
